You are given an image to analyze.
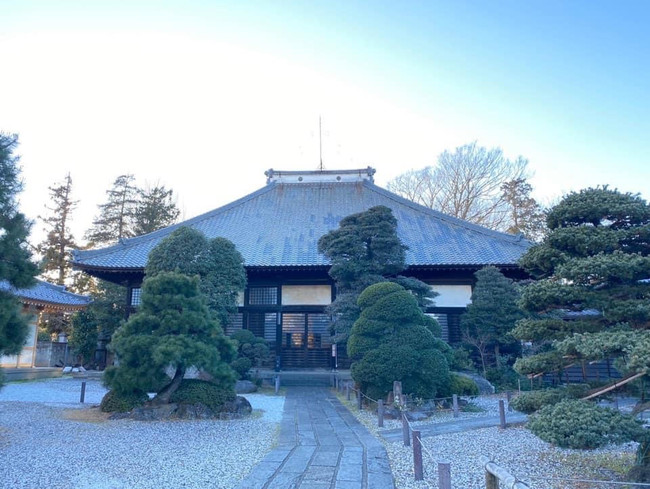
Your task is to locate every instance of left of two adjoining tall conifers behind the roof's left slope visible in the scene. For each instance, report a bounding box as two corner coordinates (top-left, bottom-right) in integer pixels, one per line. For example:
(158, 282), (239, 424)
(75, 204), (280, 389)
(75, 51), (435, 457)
(85, 175), (138, 245)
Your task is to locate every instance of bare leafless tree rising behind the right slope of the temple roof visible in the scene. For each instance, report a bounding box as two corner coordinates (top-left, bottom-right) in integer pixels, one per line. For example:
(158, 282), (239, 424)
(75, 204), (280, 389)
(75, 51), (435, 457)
(388, 142), (528, 230)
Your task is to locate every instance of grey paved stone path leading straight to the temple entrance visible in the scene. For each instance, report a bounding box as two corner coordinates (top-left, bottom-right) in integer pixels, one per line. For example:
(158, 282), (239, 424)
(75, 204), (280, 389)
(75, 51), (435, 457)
(237, 386), (395, 489)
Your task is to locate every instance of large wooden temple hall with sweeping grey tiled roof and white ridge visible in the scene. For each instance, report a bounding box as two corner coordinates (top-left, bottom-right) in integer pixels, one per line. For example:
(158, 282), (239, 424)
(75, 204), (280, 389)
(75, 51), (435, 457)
(73, 167), (530, 368)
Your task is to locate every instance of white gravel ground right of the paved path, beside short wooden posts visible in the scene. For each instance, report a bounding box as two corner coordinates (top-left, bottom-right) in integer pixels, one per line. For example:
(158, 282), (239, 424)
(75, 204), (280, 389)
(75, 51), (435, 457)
(347, 396), (636, 489)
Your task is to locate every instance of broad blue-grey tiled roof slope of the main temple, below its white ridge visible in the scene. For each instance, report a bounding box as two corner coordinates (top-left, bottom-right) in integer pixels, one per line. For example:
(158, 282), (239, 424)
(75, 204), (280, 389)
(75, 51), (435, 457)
(73, 180), (530, 269)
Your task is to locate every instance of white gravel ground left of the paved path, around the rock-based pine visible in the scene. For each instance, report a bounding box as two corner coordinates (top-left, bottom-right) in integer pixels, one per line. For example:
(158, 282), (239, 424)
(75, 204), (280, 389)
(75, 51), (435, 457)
(0, 378), (284, 489)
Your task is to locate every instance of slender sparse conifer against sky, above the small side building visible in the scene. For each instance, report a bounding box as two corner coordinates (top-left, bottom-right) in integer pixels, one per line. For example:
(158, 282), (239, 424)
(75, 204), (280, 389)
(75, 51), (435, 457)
(38, 173), (79, 285)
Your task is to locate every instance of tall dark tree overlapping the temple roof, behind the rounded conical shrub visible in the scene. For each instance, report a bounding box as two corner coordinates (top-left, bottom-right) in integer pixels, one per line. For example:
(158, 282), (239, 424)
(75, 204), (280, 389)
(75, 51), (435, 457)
(318, 206), (433, 343)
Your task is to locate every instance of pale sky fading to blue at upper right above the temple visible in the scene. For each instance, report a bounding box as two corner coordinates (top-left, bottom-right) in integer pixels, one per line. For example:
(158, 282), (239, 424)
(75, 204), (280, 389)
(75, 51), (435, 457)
(0, 0), (650, 241)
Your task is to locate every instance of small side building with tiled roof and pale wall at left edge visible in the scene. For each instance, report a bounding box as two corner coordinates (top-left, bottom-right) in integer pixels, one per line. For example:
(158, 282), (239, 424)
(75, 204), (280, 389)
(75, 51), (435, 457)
(0, 280), (91, 368)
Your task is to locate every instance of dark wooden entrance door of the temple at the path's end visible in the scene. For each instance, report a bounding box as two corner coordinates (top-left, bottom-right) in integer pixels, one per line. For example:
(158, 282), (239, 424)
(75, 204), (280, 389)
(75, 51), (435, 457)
(282, 313), (332, 368)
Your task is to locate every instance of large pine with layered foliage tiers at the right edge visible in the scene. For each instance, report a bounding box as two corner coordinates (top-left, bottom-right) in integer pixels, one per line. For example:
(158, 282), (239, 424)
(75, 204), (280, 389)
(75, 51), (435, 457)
(513, 187), (650, 380)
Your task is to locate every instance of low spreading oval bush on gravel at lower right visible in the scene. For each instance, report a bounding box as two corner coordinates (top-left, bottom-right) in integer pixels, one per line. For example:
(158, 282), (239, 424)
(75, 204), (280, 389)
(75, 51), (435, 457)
(528, 399), (644, 449)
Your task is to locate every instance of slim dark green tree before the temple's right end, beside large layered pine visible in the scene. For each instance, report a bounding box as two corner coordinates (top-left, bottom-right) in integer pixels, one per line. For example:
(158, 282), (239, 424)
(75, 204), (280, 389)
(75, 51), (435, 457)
(460, 267), (524, 375)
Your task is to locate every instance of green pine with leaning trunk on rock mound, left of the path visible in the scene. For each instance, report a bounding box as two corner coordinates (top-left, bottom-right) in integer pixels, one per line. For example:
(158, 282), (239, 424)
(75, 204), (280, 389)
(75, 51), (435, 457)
(104, 272), (235, 402)
